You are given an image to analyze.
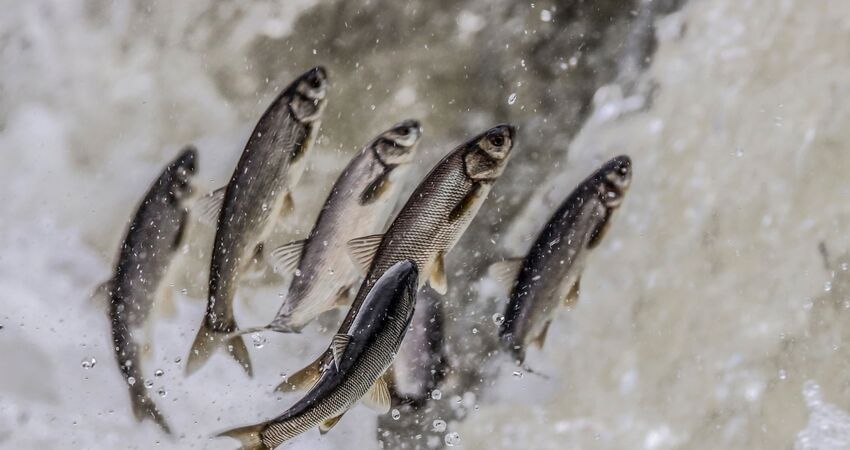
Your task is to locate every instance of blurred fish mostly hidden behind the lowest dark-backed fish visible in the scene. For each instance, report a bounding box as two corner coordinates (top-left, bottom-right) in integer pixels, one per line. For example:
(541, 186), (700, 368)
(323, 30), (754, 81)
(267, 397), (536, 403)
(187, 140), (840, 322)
(390, 289), (448, 408)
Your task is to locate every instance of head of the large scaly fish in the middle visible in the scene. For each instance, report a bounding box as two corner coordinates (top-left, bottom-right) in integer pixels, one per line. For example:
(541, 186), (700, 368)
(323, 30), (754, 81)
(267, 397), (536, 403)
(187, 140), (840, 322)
(463, 125), (516, 181)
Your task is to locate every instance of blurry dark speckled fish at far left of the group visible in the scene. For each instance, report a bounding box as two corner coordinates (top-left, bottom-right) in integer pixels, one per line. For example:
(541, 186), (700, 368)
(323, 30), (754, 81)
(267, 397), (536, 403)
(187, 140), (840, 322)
(97, 146), (197, 434)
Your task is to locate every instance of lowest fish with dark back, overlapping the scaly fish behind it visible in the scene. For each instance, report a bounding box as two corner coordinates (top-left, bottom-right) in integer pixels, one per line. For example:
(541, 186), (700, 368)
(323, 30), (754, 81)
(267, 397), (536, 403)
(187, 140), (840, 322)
(219, 261), (419, 450)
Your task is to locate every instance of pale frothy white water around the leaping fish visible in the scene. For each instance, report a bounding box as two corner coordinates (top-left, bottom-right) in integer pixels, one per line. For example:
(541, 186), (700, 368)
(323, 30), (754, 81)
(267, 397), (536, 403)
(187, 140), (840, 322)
(0, 0), (850, 449)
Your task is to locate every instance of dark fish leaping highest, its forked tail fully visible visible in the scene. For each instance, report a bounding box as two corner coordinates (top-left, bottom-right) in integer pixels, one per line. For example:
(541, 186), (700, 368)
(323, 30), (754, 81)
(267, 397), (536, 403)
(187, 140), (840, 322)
(186, 67), (328, 376)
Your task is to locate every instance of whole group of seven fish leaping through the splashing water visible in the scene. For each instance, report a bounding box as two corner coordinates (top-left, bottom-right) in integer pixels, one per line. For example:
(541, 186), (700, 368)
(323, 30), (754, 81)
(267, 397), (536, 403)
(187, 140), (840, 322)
(95, 67), (632, 450)
